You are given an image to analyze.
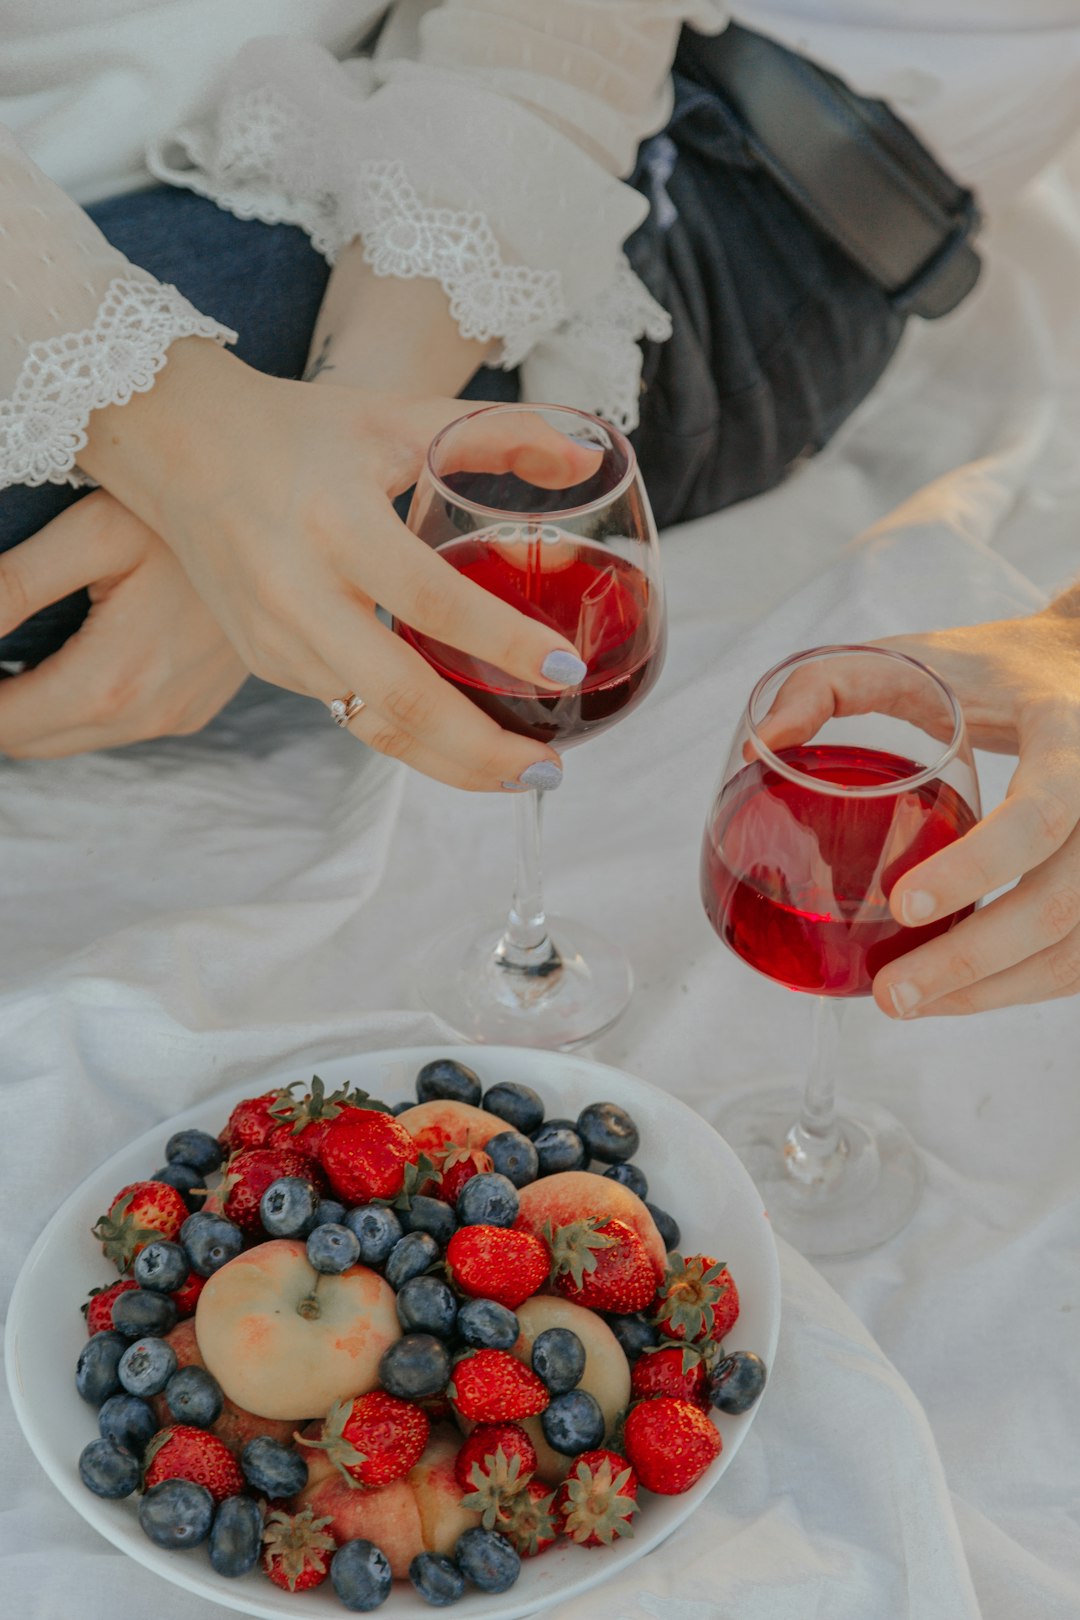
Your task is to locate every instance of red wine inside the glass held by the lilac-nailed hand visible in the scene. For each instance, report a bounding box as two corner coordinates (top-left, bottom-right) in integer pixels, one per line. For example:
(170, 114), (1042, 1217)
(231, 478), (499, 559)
(398, 523), (665, 748)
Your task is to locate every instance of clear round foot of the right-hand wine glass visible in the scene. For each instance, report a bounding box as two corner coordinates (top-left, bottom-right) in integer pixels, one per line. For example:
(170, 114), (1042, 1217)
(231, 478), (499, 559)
(719, 1087), (923, 1259)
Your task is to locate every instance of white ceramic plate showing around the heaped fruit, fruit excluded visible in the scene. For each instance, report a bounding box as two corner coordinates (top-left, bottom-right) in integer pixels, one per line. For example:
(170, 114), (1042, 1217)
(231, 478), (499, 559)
(5, 1047), (780, 1620)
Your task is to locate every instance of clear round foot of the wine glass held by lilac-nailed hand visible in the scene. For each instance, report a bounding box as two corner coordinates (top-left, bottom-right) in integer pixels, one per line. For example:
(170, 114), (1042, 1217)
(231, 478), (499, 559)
(416, 917), (633, 1047)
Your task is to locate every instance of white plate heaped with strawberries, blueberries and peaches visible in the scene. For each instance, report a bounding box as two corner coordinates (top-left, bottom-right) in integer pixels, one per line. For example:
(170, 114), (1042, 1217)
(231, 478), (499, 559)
(6, 1047), (779, 1620)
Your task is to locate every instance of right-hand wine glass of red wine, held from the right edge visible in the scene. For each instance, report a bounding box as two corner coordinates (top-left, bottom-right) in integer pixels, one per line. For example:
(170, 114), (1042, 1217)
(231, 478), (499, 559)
(701, 646), (980, 1257)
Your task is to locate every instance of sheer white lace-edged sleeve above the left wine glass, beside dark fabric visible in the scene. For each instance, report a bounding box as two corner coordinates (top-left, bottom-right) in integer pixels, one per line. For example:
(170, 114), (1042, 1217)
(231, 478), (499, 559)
(149, 0), (727, 426)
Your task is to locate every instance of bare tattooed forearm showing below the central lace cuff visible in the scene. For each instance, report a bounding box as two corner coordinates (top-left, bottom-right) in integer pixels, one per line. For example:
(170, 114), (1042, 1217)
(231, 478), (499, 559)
(304, 241), (491, 397)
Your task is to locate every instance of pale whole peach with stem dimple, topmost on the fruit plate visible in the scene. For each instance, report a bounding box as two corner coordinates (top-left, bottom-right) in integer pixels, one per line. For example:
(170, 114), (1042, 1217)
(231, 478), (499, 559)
(194, 1238), (402, 1422)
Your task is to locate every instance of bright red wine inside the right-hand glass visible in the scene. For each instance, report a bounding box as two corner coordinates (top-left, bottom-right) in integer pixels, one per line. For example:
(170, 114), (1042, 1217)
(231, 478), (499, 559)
(701, 742), (975, 996)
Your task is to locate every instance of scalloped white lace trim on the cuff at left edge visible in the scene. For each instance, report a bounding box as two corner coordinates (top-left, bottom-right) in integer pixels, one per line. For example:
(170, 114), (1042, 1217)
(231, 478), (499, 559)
(0, 275), (236, 488)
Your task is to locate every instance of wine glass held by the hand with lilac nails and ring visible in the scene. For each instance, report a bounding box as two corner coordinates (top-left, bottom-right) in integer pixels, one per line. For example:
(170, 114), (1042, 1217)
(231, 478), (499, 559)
(397, 405), (665, 1047)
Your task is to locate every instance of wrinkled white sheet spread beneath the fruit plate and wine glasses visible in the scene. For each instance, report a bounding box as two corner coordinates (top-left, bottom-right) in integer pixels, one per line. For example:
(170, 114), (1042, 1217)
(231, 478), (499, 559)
(0, 142), (1080, 1620)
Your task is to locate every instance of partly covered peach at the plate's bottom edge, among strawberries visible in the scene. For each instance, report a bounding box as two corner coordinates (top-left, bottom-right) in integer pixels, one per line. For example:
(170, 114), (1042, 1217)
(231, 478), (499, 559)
(295, 1429), (479, 1580)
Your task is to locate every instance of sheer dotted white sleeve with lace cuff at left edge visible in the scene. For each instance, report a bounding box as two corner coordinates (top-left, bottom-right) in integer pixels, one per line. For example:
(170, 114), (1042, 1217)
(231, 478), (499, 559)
(0, 128), (235, 489)
